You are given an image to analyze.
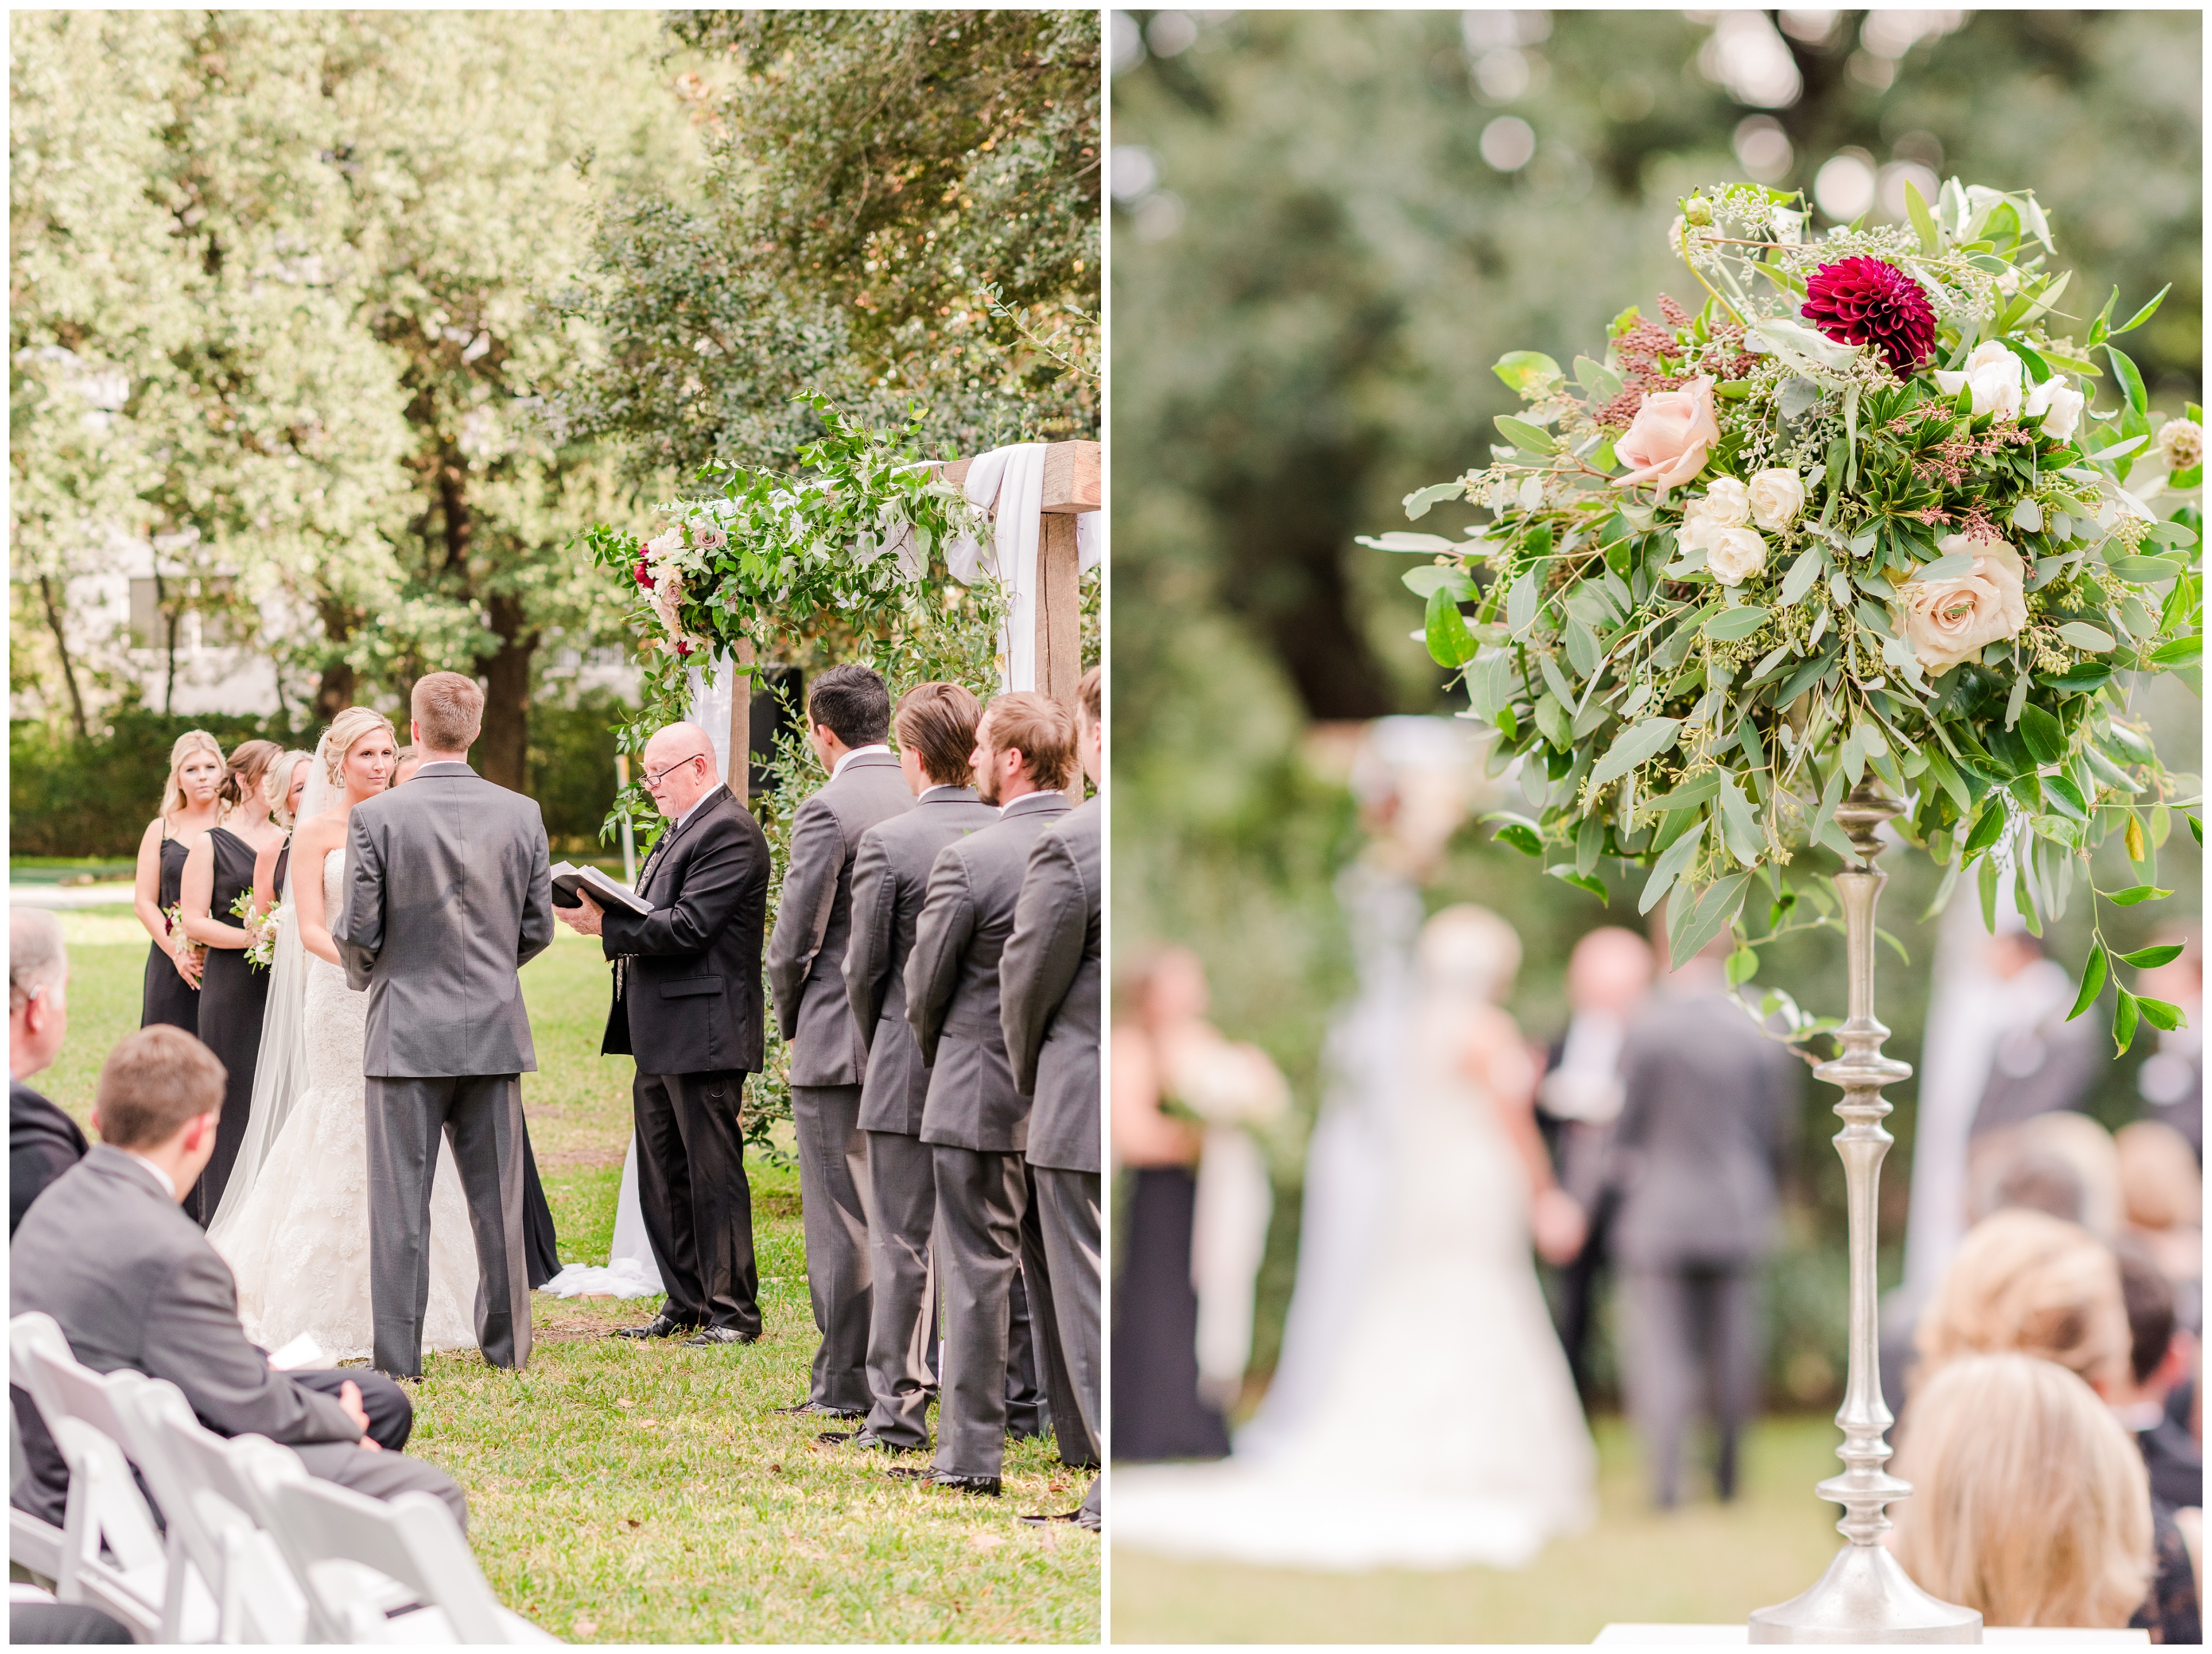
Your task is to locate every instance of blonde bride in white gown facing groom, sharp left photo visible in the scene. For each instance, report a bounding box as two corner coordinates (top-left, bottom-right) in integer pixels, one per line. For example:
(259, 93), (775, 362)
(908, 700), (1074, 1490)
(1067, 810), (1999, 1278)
(208, 708), (478, 1362)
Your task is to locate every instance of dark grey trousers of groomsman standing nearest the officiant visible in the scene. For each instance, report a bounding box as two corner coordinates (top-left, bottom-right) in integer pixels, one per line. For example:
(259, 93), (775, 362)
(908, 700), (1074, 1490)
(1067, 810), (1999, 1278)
(792, 1086), (870, 1418)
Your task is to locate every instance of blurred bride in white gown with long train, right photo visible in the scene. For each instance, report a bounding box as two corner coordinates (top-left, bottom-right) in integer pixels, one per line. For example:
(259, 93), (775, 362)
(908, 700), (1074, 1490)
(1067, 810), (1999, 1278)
(1113, 906), (1597, 1570)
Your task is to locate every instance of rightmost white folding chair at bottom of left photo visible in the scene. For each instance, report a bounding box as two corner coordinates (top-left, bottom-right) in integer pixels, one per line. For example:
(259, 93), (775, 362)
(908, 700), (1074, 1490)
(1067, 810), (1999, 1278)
(261, 1477), (560, 1643)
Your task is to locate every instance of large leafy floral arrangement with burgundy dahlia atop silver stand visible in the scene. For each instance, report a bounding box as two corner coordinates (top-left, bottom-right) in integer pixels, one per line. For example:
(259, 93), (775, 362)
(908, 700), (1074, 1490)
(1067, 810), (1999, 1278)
(1363, 179), (2203, 1048)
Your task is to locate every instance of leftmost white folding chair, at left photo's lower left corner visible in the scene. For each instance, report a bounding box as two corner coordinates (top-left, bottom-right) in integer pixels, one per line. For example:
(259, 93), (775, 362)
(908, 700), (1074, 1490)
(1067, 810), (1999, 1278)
(11, 1320), (215, 1643)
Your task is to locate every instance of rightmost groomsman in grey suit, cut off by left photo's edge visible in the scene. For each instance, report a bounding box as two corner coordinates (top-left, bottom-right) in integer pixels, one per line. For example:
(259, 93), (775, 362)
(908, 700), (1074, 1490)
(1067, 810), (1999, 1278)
(998, 666), (1106, 1530)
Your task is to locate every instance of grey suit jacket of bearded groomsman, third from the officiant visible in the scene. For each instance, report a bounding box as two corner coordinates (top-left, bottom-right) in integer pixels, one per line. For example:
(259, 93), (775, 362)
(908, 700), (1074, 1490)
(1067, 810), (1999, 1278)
(907, 792), (1069, 1152)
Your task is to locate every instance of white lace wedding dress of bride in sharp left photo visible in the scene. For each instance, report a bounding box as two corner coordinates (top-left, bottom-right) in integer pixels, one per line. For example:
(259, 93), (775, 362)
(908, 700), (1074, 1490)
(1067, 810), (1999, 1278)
(208, 849), (478, 1362)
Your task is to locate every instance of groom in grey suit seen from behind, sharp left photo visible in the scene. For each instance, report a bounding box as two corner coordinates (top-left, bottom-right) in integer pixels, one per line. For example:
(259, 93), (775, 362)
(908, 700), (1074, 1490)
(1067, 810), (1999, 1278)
(332, 672), (553, 1378)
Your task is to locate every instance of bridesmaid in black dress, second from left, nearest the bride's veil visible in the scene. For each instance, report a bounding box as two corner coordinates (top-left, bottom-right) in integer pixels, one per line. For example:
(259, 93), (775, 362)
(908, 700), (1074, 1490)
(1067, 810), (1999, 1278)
(181, 741), (283, 1229)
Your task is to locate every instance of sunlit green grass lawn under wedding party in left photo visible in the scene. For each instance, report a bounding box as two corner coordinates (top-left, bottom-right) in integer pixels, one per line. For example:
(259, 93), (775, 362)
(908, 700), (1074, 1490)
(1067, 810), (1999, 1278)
(38, 909), (1100, 1643)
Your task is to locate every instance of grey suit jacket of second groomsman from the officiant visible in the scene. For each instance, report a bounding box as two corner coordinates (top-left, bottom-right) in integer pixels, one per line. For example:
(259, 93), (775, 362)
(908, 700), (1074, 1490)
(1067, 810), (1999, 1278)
(845, 787), (998, 1136)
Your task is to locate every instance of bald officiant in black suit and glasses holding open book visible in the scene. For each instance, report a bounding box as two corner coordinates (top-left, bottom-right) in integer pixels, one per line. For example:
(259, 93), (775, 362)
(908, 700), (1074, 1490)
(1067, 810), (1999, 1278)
(556, 723), (768, 1344)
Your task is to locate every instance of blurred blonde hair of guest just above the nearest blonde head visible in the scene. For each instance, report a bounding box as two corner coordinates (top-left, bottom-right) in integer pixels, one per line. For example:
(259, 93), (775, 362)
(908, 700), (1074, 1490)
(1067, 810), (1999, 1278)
(1914, 1207), (2128, 1411)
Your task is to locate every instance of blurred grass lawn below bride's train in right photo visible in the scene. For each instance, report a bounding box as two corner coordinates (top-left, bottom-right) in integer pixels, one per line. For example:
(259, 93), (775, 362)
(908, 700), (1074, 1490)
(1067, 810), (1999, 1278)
(1113, 1418), (1843, 1643)
